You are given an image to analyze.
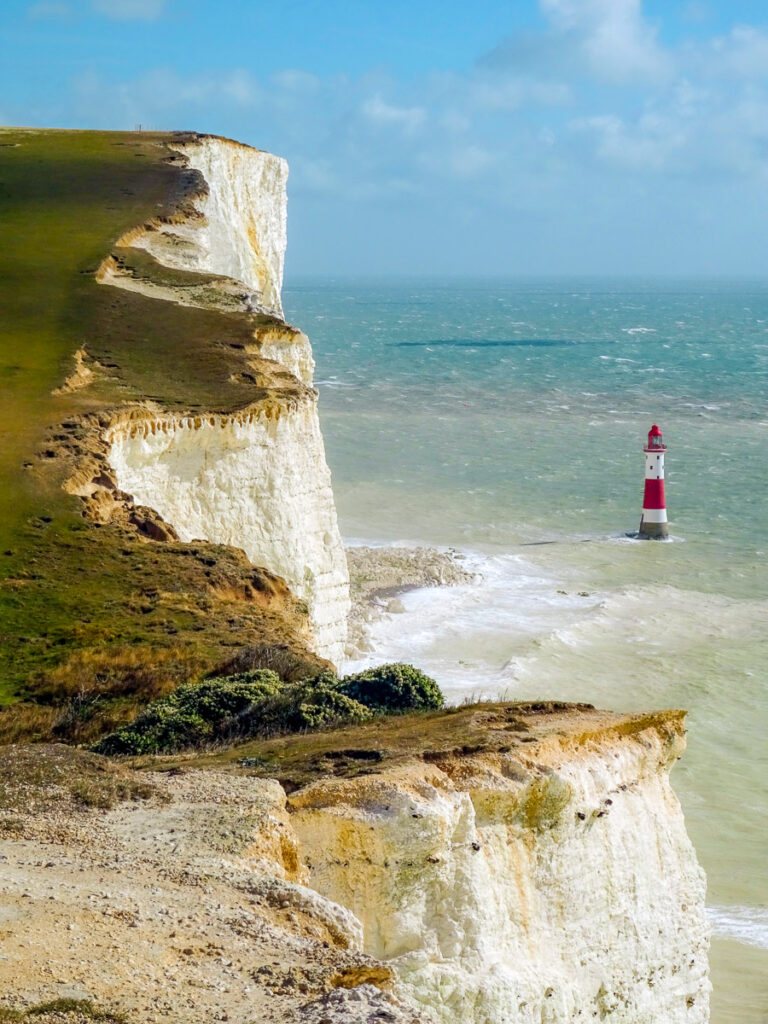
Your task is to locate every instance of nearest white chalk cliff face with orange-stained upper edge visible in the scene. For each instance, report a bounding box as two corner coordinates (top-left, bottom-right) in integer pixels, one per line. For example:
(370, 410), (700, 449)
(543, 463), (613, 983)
(290, 716), (709, 1024)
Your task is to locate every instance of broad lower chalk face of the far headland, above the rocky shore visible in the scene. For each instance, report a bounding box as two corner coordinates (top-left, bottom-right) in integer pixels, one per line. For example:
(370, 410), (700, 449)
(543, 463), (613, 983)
(108, 396), (349, 664)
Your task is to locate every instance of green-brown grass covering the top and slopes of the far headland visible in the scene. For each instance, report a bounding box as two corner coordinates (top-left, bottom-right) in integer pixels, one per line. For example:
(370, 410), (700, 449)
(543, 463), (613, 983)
(0, 129), (319, 716)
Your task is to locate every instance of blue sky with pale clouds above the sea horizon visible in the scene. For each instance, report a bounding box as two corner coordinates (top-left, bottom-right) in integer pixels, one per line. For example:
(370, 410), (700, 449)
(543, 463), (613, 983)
(0, 0), (768, 282)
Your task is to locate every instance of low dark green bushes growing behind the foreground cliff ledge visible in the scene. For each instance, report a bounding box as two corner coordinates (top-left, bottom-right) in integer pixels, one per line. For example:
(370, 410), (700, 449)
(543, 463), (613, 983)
(93, 665), (443, 755)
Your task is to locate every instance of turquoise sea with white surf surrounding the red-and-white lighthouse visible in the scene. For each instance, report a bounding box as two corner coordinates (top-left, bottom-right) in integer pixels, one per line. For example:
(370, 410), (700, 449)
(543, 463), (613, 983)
(284, 279), (768, 1024)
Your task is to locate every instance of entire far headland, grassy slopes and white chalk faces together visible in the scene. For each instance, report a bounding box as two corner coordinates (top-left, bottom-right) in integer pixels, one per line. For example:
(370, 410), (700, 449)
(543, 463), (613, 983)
(0, 129), (349, 742)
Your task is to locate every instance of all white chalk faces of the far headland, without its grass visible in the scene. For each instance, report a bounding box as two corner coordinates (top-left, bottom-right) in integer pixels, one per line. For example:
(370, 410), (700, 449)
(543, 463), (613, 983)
(98, 137), (349, 664)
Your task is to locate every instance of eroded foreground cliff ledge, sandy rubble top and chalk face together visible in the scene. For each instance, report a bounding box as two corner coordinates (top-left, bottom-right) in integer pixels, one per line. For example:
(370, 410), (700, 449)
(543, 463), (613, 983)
(0, 703), (709, 1024)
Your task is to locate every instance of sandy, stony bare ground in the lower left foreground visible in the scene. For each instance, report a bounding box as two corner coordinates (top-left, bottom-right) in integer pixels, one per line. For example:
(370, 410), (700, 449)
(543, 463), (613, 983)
(0, 745), (420, 1024)
